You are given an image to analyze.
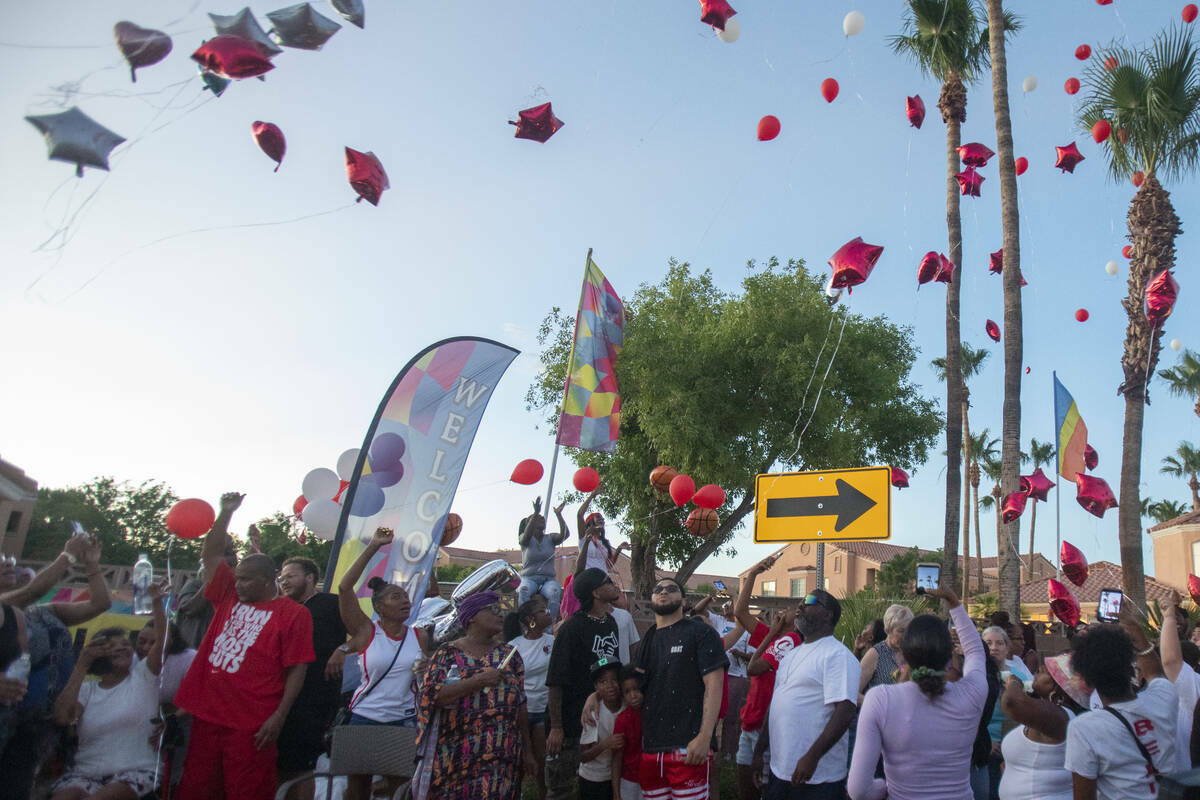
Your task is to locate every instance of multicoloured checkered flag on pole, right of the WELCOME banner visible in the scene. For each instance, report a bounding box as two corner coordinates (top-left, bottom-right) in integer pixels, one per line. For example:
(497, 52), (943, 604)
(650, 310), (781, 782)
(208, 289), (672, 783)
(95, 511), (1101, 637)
(558, 251), (625, 450)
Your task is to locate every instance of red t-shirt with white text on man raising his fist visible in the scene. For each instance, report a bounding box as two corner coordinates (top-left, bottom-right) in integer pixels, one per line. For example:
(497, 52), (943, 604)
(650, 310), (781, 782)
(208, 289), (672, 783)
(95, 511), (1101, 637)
(175, 561), (314, 730)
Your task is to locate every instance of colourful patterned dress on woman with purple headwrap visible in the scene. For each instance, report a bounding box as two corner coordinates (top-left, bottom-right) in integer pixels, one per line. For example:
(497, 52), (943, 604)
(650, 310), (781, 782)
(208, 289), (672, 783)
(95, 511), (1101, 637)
(418, 643), (526, 800)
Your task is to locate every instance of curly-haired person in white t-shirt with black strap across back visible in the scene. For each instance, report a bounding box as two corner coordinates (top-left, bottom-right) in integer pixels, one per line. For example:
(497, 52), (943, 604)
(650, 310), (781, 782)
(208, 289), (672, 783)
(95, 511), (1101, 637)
(1066, 609), (1180, 800)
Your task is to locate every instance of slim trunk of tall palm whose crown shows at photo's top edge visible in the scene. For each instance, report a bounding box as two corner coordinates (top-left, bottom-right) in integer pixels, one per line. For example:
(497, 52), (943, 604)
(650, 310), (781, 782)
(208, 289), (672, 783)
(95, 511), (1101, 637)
(941, 82), (971, 601)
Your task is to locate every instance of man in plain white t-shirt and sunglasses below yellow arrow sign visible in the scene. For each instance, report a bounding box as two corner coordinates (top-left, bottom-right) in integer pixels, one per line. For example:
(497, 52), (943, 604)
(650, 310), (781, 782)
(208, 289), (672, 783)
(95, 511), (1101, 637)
(760, 589), (860, 800)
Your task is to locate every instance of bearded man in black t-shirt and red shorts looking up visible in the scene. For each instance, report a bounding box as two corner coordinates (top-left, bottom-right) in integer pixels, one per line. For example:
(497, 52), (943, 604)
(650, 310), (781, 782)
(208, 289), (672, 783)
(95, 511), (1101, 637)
(637, 578), (730, 800)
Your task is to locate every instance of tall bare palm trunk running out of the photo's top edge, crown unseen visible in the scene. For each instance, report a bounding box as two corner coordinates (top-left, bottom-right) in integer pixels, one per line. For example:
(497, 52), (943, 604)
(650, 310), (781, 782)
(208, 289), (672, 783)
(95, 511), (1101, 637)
(988, 0), (1025, 619)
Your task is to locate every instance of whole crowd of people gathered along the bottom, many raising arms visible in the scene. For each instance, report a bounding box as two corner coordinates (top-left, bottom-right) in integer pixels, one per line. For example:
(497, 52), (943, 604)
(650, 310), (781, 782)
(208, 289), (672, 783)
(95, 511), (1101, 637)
(0, 493), (1200, 800)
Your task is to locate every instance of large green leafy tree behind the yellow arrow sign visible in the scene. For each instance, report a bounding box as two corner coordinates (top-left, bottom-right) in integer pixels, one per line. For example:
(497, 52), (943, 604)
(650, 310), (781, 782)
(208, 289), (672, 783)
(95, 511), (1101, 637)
(526, 259), (940, 595)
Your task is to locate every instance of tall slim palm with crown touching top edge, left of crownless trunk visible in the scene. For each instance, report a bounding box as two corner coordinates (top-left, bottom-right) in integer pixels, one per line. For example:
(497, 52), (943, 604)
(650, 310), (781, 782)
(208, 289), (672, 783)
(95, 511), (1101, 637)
(889, 0), (988, 587)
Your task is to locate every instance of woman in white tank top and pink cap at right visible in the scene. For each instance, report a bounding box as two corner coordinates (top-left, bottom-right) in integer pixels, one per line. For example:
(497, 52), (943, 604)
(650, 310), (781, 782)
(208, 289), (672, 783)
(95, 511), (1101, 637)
(1000, 654), (1088, 800)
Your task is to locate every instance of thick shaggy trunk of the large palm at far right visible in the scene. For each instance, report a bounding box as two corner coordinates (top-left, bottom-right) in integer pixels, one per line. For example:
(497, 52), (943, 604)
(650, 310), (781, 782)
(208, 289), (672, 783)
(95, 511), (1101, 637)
(1117, 173), (1182, 607)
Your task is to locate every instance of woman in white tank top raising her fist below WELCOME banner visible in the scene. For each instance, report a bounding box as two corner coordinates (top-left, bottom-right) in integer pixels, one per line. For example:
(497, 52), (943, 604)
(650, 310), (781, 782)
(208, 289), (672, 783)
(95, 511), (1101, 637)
(337, 528), (430, 800)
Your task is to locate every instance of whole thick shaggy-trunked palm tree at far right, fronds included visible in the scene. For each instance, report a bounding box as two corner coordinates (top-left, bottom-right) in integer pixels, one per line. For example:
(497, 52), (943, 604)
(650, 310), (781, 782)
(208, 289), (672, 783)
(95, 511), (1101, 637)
(1078, 29), (1200, 607)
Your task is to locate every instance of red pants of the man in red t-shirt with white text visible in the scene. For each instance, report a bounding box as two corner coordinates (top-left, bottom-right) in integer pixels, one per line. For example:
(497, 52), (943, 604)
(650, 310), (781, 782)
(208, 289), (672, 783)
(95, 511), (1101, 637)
(179, 717), (275, 800)
